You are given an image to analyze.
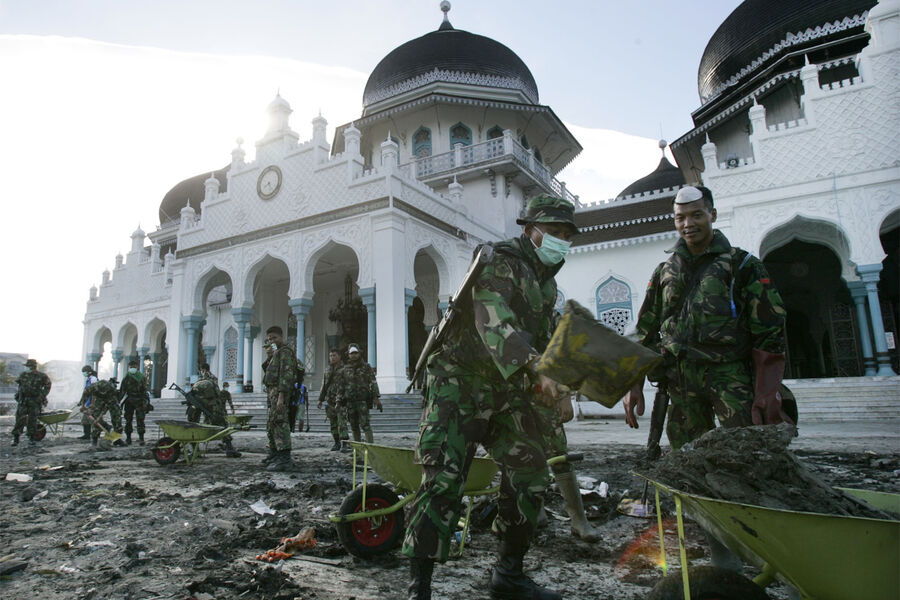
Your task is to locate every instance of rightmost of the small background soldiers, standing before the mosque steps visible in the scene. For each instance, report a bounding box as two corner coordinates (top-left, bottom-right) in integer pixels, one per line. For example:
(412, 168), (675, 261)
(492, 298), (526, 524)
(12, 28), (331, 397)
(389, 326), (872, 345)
(336, 344), (383, 444)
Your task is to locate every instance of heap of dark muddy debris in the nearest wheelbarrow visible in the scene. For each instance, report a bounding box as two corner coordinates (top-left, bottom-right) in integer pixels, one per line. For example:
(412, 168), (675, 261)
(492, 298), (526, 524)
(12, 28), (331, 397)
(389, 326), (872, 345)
(642, 424), (893, 519)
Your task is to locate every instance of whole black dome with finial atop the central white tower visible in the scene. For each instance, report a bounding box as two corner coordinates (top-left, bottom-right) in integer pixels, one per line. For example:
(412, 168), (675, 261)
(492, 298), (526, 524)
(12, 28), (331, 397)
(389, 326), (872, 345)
(363, 21), (538, 106)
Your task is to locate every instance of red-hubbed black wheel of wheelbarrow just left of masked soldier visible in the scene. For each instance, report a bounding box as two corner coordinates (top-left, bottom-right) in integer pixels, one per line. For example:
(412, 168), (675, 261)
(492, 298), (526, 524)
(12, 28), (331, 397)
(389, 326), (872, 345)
(337, 483), (405, 558)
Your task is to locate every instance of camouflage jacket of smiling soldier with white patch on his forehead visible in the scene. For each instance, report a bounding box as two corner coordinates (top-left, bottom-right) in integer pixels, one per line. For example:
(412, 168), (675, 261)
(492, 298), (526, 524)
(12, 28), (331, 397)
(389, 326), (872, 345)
(637, 231), (785, 363)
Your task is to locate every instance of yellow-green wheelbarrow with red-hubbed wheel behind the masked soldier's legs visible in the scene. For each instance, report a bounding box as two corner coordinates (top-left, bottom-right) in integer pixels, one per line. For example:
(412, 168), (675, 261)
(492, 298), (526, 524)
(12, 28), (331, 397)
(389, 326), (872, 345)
(328, 442), (500, 558)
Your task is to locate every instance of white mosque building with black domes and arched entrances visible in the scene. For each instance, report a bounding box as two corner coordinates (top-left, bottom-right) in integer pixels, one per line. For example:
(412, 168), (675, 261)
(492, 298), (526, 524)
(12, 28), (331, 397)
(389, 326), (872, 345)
(84, 0), (900, 412)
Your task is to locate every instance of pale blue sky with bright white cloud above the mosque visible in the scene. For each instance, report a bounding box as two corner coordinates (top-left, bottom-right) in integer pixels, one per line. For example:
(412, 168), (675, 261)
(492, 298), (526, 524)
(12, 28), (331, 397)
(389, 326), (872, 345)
(0, 0), (739, 362)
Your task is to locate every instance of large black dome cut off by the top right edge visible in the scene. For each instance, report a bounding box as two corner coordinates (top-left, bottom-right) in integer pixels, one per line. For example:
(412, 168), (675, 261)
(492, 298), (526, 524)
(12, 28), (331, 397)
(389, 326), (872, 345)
(697, 0), (875, 102)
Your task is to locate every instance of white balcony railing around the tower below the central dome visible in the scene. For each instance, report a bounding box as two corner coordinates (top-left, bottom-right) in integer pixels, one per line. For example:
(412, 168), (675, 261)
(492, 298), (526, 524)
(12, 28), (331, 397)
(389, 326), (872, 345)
(400, 135), (580, 206)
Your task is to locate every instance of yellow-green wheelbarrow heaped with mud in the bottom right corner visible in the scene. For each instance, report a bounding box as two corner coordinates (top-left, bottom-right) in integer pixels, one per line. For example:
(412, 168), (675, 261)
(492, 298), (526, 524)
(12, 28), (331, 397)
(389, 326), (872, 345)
(639, 475), (900, 600)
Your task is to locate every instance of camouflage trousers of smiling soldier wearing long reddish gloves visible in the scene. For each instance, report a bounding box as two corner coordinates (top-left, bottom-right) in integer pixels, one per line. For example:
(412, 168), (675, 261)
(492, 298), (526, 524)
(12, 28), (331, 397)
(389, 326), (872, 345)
(666, 361), (753, 450)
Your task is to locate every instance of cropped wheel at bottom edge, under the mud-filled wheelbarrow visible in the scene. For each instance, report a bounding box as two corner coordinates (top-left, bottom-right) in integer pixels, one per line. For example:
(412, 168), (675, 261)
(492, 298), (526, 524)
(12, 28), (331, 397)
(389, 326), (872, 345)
(647, 567), (770, 600)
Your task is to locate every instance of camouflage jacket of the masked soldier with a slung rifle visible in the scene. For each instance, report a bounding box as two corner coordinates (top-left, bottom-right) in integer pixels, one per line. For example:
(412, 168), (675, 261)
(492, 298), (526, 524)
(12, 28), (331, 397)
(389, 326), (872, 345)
(428, 234), (563, 386)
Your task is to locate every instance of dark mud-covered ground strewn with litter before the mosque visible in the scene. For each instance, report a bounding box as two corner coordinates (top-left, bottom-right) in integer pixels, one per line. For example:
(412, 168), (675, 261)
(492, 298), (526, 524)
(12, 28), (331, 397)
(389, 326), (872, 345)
(0, 428), (900, 600)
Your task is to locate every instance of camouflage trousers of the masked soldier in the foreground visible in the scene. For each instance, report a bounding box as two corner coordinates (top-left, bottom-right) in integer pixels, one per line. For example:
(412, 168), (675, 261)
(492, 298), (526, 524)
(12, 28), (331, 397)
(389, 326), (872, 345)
(403, 375), (549, 561)
